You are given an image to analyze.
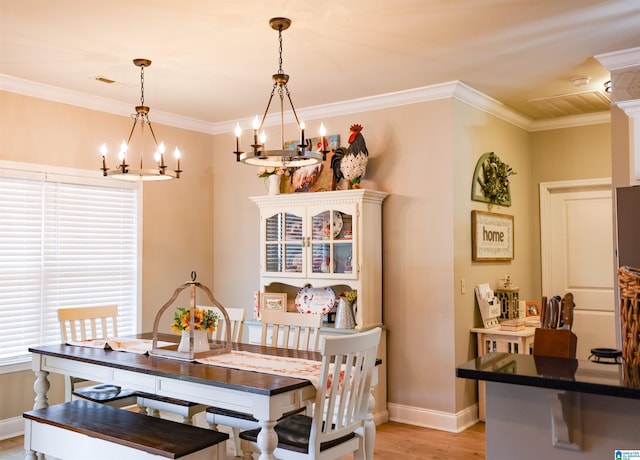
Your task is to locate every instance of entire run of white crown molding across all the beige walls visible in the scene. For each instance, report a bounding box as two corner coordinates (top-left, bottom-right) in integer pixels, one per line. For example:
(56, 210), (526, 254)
(0, 71), (608, 135)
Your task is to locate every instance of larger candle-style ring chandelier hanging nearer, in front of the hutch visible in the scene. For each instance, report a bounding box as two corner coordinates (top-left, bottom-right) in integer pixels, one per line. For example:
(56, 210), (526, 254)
(233, 18), (324, 167)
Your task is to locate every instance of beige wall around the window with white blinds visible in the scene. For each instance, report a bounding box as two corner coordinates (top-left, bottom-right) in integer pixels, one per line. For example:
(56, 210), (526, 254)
(0, 91), (213, 420)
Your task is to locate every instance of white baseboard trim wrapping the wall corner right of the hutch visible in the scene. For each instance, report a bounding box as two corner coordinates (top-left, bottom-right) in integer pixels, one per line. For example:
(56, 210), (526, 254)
(387, 403), (479, 433)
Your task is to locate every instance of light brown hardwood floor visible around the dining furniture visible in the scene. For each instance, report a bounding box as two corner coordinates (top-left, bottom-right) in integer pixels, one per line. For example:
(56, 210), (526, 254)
(0, 422), (485, 460)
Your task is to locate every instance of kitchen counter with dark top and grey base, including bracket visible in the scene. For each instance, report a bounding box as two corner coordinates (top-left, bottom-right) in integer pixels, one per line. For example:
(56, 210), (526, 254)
(456, 352), (640, 460)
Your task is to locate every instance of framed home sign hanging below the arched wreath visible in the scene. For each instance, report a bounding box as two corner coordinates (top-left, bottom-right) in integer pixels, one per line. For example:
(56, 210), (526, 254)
(471, 211), (514, 262)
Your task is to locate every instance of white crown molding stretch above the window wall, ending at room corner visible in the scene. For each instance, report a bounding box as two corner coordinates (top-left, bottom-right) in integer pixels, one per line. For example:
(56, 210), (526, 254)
(0, 74), (211, 134)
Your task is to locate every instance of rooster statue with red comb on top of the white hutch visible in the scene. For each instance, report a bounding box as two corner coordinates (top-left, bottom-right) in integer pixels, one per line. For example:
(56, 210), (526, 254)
(331, 124), (369, 188)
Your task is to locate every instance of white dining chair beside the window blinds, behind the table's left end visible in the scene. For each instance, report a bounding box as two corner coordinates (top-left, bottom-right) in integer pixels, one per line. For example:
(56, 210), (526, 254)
(58, 305), (137, 407)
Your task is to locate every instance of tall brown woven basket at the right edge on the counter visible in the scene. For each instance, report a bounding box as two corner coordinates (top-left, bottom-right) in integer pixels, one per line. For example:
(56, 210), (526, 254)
(618, 267), (640, 386)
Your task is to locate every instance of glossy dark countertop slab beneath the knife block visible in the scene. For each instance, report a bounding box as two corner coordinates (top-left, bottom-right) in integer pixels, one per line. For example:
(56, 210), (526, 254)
(456, 352), (640, 399)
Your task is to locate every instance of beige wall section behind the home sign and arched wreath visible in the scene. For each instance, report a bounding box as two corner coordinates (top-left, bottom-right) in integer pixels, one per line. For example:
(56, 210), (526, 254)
(451, 102), (533, 412)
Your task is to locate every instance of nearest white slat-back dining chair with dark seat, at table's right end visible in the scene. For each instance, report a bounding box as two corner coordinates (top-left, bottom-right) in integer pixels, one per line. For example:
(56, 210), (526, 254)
(240, 327), (381, 460)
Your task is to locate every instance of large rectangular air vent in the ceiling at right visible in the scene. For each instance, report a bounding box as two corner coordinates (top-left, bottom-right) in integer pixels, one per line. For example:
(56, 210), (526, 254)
(527, 91), (611, 118)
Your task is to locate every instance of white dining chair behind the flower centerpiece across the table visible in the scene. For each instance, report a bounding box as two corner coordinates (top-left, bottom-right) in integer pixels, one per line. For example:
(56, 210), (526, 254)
(137, 305), (246, 425)
